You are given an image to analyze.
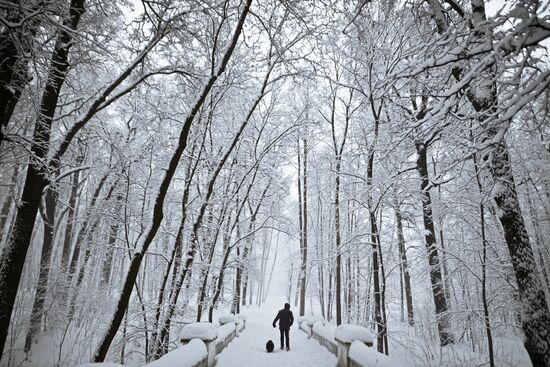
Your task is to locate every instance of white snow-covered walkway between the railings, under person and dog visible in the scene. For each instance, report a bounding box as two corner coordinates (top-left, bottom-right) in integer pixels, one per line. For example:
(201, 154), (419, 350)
(216, 303), (336, 367)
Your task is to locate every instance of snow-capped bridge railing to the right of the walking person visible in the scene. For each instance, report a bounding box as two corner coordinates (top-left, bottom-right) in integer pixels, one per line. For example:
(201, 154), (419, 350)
(298, 316), (403, 367)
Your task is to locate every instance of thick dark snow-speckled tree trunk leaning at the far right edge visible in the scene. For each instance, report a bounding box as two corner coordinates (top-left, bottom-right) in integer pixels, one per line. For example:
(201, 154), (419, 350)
(430, 0), (550, 360)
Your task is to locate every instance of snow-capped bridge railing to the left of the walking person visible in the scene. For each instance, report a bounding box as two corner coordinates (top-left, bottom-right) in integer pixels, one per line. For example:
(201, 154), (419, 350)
(77, 314), (246, 367)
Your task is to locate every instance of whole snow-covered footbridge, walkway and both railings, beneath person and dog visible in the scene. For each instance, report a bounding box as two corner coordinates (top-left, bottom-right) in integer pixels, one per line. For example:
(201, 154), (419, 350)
(131, 305), (403, 367)
